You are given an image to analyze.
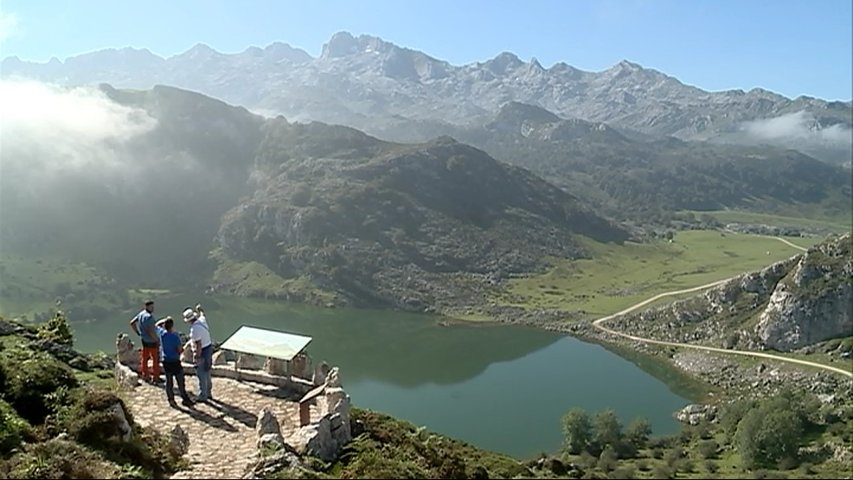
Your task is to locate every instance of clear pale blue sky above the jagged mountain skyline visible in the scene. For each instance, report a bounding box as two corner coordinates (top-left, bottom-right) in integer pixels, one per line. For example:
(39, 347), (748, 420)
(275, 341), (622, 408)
(0, 0), (853, 100)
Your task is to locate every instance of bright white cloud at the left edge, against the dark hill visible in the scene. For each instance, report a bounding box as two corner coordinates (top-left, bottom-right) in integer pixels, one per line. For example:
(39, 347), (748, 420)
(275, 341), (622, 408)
(0, 80), (157, 190)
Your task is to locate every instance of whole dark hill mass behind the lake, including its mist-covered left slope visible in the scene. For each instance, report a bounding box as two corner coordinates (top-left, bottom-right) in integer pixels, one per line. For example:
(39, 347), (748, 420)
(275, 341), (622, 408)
(0, 85), (627, 310)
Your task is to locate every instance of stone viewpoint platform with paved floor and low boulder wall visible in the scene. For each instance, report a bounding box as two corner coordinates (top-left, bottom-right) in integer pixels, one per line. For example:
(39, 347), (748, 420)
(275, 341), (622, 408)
(115, 334), (352, 478)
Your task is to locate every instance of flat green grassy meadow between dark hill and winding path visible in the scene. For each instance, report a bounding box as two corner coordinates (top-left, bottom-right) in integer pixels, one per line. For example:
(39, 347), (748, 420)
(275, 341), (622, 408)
(492, 230), (820, 317)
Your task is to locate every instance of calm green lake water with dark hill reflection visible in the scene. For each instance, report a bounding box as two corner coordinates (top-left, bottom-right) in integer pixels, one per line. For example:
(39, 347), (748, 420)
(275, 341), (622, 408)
(74, 297), (691, 458)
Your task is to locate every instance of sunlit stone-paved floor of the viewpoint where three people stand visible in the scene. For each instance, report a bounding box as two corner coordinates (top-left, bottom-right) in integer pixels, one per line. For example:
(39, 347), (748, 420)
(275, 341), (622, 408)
(126, 376), (320, 478)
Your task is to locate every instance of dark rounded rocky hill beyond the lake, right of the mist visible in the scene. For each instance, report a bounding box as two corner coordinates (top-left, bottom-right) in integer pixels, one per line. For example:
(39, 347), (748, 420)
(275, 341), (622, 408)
(215, 124), (627, 310)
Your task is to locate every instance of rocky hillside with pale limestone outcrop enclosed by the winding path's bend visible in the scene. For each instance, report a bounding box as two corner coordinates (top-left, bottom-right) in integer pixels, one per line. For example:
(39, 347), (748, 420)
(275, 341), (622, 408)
(613, 234), (853, 352)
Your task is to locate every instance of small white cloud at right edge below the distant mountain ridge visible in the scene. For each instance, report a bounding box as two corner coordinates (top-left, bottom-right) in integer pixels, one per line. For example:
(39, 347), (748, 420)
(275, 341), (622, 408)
(741, 111), (853, 148)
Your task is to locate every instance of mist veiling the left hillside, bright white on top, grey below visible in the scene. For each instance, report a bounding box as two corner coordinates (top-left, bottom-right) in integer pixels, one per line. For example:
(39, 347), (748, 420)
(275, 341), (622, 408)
(0, 80), (260, 284)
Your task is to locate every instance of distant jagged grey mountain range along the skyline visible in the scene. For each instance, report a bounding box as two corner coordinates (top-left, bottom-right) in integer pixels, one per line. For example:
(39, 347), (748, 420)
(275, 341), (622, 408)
(5, 32), (853, 163)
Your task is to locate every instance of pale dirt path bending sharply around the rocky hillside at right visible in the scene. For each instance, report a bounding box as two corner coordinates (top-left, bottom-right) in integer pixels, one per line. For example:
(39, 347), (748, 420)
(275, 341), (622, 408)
(592, 237), (853, 378)
